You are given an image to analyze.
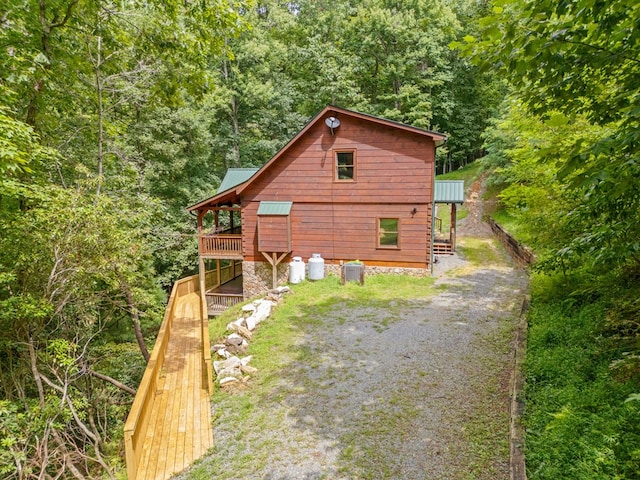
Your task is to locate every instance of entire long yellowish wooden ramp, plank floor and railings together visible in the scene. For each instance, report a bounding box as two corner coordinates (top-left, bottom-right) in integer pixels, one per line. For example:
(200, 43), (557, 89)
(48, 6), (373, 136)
(125, 277), (213, 480)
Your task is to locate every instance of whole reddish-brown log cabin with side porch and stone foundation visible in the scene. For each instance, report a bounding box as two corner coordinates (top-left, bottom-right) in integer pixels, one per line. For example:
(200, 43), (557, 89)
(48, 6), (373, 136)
(188, 106), (455, 314)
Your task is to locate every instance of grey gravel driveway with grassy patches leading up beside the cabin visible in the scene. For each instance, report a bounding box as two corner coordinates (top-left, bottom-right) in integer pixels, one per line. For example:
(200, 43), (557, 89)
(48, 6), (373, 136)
(183, 181), (527, 480)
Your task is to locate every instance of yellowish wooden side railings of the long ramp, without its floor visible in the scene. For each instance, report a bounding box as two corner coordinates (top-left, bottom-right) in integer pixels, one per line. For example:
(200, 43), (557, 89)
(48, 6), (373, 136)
(124, 275), (213, 480)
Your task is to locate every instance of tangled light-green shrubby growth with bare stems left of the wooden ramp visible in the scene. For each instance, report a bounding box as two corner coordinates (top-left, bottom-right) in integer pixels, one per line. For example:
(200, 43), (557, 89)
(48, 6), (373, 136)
(0, 180), (162, 478)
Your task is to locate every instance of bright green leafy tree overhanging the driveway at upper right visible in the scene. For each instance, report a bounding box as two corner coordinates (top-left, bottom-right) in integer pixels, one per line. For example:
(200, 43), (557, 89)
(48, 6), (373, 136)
(462, 0), (640, 271)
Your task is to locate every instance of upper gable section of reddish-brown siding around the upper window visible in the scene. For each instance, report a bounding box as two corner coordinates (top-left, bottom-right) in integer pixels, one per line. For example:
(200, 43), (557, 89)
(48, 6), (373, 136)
(243, 117), (435, 207)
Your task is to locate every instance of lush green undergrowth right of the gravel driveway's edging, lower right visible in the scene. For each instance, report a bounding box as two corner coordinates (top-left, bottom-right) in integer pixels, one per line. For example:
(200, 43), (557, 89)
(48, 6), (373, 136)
(525, 276), (640, 480)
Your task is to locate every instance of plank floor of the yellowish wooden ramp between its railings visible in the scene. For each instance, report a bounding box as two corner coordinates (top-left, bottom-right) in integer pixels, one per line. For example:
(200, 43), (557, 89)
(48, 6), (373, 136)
(136, 293), (213, 480)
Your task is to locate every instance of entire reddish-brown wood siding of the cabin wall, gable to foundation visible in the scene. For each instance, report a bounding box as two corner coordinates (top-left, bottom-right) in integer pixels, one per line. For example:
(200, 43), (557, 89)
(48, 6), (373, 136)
(242, 117), (435, 268)
